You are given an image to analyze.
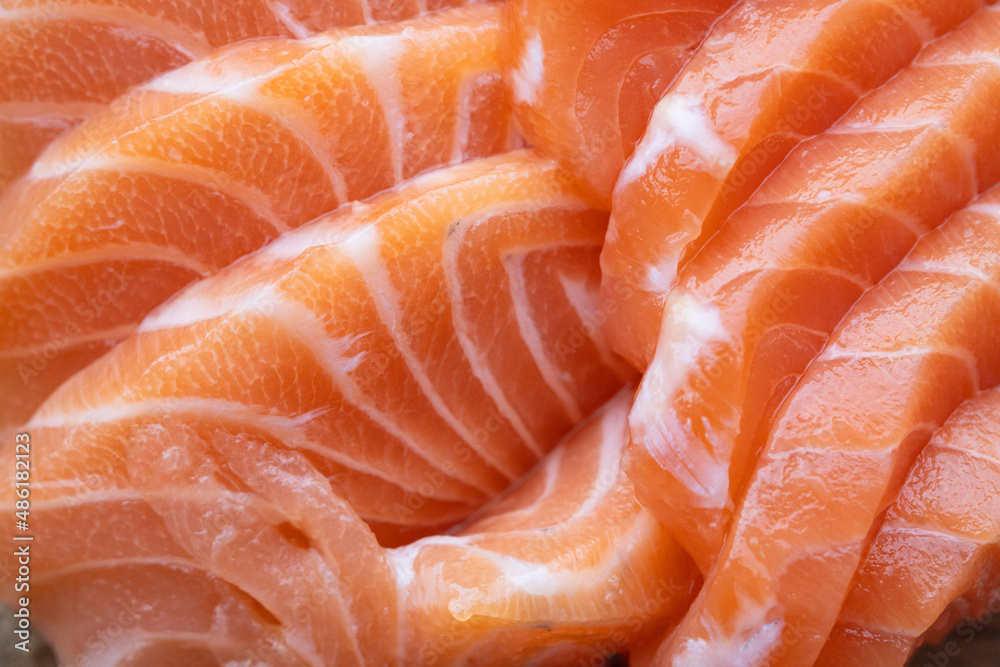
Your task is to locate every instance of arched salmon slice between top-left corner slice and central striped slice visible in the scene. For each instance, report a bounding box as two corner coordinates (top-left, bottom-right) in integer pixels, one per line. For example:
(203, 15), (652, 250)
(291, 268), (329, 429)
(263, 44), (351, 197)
(0, 4), (519, 428)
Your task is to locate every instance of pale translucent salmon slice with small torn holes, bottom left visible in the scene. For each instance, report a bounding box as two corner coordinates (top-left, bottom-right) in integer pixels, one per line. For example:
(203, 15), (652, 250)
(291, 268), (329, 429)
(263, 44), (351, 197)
(3, 415), (398, 667)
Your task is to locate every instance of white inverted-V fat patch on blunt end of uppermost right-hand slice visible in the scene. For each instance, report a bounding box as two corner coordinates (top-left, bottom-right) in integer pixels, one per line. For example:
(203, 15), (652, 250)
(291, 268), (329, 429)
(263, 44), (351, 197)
(619, 94), (737, 183)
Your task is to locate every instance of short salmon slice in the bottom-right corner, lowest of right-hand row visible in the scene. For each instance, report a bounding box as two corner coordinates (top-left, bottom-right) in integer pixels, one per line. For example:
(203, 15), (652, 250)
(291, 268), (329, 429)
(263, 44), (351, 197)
(817, 384), (1000, 667)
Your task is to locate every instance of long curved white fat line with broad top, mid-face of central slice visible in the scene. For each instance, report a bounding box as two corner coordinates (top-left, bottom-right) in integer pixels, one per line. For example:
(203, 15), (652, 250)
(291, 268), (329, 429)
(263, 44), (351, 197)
(337, 225), (519, 481)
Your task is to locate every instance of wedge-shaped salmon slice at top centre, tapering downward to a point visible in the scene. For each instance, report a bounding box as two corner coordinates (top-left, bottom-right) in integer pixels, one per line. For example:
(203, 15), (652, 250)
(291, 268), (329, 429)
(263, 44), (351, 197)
(502, 0), (734, 206)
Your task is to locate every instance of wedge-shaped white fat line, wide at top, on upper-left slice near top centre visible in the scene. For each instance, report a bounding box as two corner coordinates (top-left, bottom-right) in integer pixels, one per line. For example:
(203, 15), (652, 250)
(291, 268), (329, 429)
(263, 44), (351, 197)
(339, 32), (409, 183)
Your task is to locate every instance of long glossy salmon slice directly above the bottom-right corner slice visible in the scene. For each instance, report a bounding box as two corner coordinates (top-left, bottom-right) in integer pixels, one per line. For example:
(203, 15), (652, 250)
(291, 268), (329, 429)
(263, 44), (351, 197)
(664, 181), (1000, 665)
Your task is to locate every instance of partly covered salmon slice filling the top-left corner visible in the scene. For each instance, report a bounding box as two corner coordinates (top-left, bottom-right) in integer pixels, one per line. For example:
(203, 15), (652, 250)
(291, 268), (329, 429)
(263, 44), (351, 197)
(0, 0), (465, 192)
